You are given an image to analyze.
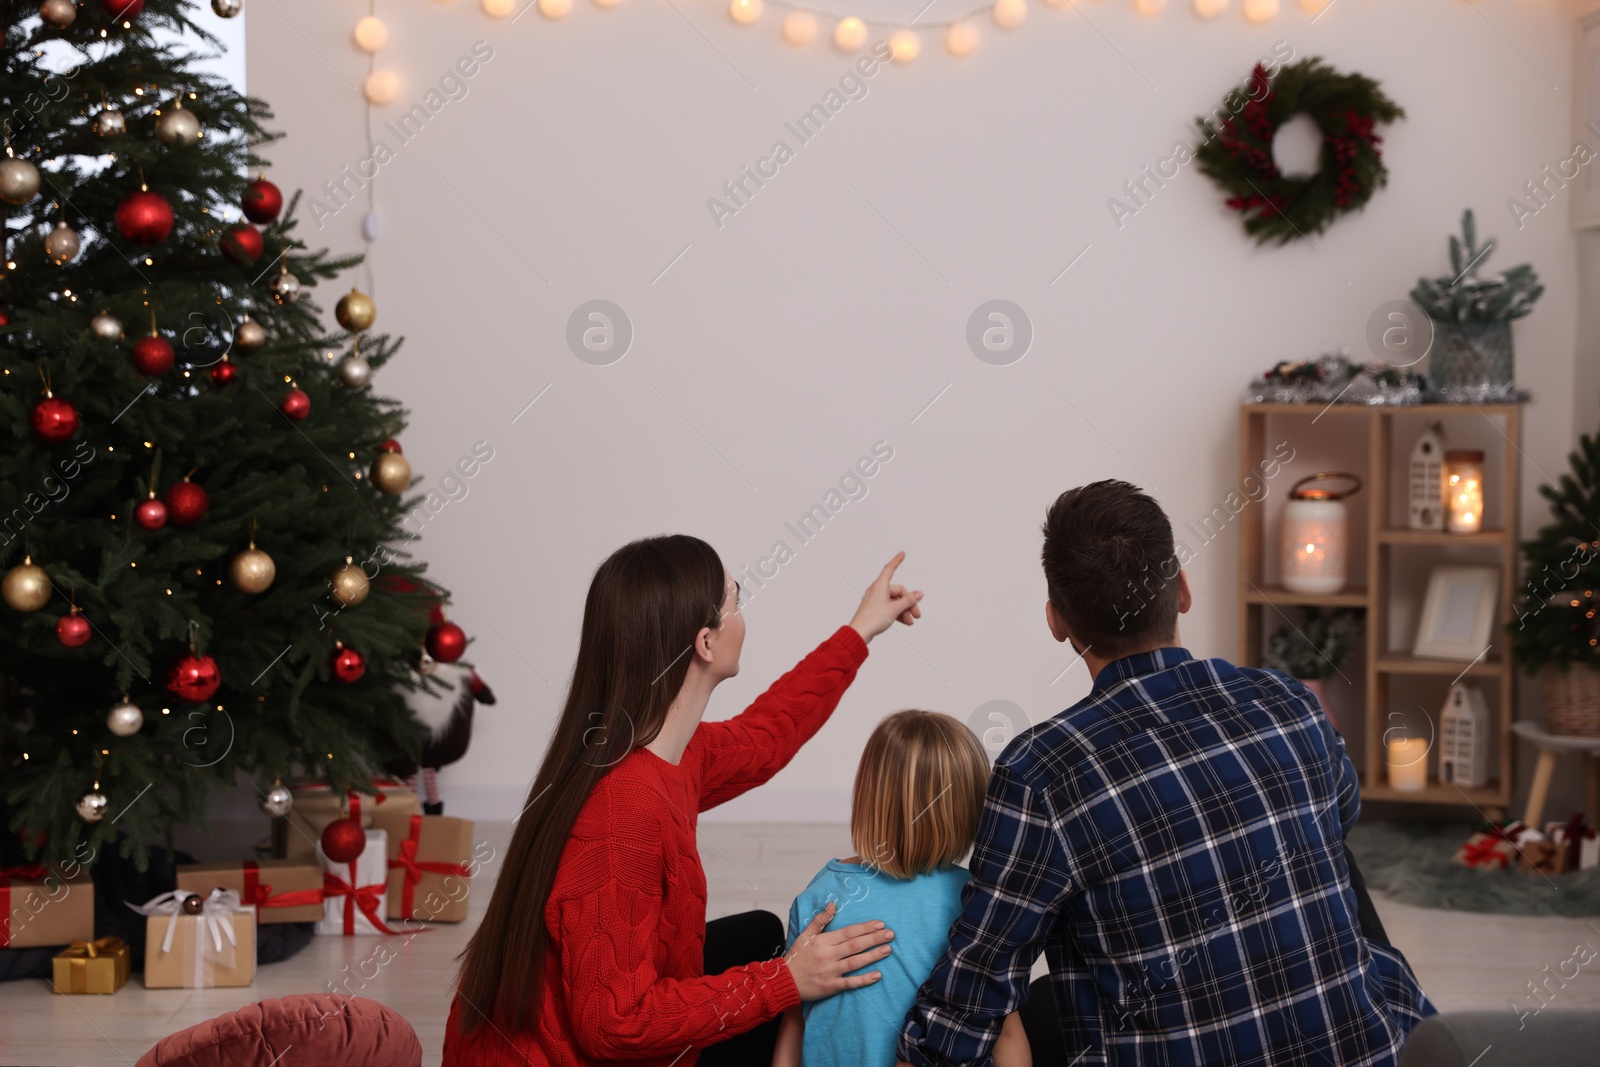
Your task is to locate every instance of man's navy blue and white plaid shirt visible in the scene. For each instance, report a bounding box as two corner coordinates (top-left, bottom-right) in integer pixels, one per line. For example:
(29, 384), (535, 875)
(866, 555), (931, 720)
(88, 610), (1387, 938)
(898, 648), (1434, 1067)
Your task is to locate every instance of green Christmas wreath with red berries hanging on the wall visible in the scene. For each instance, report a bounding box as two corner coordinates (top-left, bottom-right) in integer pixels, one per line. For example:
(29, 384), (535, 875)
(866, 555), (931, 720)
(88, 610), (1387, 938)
(1195, 56), (1405, 245)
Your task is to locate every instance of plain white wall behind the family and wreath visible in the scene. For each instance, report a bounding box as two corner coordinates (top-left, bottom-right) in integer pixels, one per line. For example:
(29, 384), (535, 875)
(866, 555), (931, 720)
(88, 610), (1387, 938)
(246, 0), (1592, 821)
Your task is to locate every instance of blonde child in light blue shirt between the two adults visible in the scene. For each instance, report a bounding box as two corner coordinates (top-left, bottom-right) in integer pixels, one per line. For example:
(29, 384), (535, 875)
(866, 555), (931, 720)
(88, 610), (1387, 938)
(773, 710), (1032, 1067)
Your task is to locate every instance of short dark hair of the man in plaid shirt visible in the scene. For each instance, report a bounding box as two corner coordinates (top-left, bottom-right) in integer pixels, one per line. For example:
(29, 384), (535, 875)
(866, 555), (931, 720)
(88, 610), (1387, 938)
(1042, 480), (1178, 659)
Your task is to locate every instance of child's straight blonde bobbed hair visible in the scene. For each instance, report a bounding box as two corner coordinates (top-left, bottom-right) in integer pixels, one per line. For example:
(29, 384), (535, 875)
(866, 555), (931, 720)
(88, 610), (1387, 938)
(850, 710), (989, 878)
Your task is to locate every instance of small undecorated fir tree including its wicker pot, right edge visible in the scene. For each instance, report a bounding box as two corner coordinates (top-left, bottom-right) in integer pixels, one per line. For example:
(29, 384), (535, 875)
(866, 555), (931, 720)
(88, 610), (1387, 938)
(1507, 434), (1600, 737)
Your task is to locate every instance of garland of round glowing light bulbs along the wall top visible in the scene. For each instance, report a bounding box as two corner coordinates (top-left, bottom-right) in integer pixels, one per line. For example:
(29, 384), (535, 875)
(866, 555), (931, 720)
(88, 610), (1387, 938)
(354, 0), (1333, 97)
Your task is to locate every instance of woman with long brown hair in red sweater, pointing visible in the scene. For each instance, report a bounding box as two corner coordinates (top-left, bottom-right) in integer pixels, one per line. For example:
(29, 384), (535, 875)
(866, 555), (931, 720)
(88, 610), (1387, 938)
(445, 534), (922, 1067)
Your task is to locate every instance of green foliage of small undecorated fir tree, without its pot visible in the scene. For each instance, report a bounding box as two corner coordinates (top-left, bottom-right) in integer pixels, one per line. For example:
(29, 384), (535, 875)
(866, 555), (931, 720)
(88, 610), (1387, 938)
(1510, 434), (1600, 673)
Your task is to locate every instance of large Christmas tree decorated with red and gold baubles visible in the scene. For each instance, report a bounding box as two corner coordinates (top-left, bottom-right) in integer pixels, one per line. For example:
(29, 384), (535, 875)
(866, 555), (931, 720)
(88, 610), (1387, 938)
(0, 0), (461, 867)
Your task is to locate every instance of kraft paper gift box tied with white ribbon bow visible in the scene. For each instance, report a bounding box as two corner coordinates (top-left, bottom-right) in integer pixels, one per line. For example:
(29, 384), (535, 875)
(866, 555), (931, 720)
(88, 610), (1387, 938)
(128, 889), (256, 989)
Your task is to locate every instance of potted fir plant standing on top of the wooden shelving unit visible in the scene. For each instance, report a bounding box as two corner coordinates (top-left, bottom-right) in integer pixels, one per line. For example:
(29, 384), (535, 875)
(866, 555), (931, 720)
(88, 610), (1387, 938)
(1411, 208), (1544, 400)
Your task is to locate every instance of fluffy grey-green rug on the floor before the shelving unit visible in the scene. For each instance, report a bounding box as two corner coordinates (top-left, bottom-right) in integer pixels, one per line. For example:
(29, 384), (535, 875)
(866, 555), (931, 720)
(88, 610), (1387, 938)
(1349, 822), (1600, 915)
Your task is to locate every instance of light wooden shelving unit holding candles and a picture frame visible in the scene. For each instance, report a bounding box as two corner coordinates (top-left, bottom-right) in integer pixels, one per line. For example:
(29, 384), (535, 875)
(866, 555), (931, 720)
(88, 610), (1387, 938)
(1238, 403), (1522, 816)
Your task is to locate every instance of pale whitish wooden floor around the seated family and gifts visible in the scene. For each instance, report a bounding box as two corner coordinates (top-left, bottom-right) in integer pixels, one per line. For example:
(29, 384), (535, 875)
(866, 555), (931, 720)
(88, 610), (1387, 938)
(9, 824), (1600, 1067)
